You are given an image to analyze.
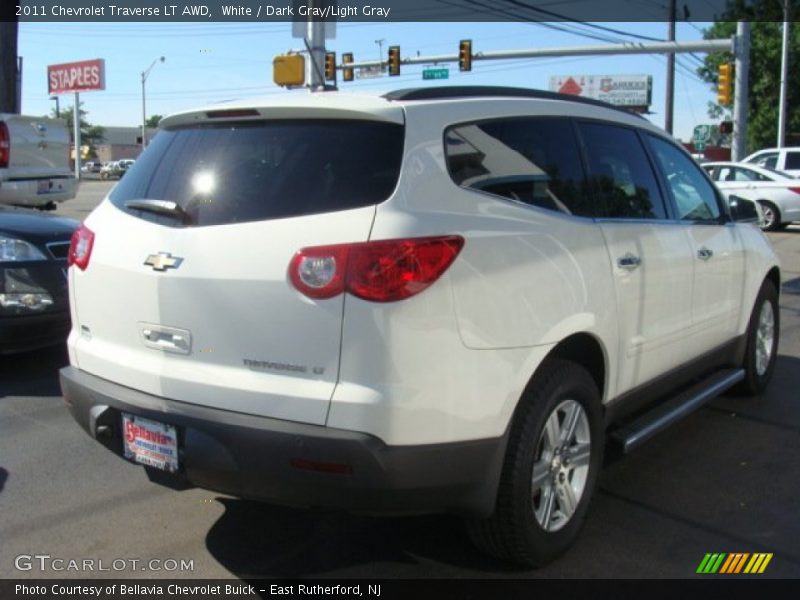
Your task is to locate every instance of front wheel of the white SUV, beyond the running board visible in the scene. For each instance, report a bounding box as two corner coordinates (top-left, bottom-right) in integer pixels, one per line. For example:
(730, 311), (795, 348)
(734, 280), (780, 396)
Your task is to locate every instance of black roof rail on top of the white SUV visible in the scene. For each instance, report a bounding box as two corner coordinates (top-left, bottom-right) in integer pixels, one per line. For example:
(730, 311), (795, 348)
(383, 85), (644, 119)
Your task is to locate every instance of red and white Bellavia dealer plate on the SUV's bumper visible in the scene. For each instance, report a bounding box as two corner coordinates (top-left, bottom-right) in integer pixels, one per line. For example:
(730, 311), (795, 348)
(122, 413), (178, 473)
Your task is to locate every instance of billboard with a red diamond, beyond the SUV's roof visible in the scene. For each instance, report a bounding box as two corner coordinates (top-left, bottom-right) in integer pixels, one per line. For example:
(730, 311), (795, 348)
(550, 75), (653, 106)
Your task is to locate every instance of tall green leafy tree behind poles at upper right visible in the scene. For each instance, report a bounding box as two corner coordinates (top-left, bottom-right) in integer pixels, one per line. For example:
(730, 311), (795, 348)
(697, 0), (800, 152)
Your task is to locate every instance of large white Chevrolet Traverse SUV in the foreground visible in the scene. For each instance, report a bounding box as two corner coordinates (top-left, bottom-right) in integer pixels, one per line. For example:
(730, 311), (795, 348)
(61, 88), (780, 564)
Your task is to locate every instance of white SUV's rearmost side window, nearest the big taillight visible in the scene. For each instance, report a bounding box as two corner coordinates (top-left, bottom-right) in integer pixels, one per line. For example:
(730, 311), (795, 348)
(445, 118), (596, 217)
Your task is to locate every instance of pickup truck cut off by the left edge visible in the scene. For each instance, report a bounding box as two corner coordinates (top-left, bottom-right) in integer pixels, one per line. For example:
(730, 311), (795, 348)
(0, 113), (77, 210)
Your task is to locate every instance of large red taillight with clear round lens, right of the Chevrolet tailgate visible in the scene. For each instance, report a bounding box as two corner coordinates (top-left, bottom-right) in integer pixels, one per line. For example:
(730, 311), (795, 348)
(289, 235), (464, 302)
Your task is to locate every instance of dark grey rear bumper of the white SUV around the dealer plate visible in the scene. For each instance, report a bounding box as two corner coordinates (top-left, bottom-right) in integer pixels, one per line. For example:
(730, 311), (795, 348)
(60, 367), (506, 516)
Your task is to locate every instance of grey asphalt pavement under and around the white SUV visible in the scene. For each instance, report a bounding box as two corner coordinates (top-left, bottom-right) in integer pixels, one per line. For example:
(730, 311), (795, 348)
(0, 181), (800, 580)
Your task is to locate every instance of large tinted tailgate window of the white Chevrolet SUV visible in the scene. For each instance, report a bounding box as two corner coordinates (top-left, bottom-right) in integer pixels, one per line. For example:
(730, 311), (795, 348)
(110, 119), (403, 227)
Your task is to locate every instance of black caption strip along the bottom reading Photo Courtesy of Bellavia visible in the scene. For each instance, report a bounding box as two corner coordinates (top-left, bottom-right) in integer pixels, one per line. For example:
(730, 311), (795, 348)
(0, 576), (800, 600)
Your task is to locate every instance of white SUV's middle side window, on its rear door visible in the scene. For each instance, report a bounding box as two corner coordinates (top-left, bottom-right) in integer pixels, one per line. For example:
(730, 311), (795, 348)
(579, 123), (666, 219)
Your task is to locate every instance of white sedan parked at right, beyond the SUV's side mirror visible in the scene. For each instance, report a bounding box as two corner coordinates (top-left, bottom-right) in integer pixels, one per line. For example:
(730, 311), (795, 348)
(703, 162), (800, 231)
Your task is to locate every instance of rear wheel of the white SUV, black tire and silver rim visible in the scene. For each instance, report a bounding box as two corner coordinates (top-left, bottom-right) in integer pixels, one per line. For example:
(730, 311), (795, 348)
(467, 360), (604, 566)
